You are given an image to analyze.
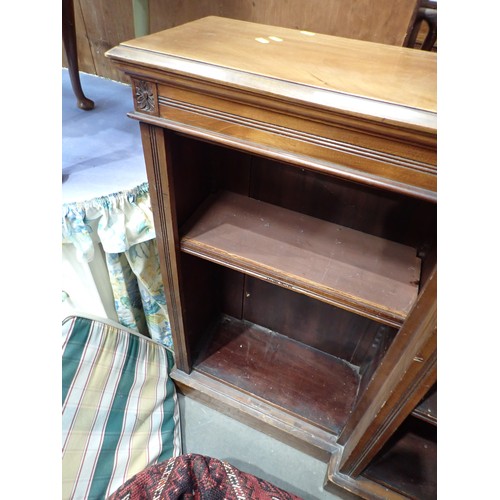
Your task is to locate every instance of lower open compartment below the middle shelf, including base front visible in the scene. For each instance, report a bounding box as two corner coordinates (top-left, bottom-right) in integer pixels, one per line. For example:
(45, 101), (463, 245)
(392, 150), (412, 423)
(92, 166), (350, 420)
(172, 252), (397, 451)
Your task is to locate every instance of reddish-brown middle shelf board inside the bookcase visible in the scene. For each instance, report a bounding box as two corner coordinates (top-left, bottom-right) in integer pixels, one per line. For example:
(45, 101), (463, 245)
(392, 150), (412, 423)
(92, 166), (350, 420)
(181, 192), (420, 326)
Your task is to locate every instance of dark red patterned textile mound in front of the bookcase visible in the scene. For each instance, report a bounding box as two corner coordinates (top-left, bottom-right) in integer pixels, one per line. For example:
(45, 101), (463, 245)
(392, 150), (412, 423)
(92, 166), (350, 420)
(109, 454), (302, 500)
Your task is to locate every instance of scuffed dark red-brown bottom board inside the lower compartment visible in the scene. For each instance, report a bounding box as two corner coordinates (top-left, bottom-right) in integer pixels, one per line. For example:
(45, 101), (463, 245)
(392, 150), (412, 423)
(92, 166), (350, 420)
(194, 316), (359, 434)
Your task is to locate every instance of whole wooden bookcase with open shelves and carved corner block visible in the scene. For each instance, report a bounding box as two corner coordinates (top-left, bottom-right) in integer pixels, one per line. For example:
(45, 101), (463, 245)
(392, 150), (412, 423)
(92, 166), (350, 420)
(107, 17), (437, 498)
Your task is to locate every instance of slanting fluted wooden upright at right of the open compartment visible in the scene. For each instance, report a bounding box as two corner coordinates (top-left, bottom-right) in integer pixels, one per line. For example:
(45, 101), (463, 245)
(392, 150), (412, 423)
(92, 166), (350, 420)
(338, 272), (437, 477)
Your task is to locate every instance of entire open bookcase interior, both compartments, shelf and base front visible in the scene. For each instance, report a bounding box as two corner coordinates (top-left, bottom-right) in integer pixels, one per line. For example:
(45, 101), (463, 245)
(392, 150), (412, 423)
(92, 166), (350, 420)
(164, 133), (434, 454)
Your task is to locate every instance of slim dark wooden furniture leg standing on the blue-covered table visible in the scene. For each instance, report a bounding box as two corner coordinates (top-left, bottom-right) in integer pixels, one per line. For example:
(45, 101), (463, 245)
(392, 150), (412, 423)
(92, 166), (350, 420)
(62, 0), (94, 111)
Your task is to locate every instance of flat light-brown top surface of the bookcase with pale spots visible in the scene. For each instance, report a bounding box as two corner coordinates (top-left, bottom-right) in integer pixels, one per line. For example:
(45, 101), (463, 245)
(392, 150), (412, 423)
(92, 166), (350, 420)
(115, 16), (437, 113)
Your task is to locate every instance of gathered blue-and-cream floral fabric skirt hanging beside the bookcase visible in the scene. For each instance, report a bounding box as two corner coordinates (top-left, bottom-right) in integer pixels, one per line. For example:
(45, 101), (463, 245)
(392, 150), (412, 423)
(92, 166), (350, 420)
(62, 183), (172, 348)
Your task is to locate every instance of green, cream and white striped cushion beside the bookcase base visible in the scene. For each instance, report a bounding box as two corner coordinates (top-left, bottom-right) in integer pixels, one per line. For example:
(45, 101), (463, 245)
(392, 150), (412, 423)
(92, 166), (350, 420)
(62, 316), (181, 500)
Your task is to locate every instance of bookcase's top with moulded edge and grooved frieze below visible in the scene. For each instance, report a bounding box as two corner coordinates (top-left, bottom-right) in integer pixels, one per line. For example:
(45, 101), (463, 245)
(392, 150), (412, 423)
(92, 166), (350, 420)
(107, 17), (437, 202)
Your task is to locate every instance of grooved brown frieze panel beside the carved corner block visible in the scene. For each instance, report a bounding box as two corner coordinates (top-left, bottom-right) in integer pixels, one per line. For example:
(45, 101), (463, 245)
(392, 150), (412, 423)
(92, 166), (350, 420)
(159, 92), (437, 174)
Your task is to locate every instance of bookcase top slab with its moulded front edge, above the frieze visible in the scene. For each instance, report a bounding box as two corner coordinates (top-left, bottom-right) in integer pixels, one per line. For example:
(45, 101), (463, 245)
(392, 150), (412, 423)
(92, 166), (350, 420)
(106, 17), (436, 139)
